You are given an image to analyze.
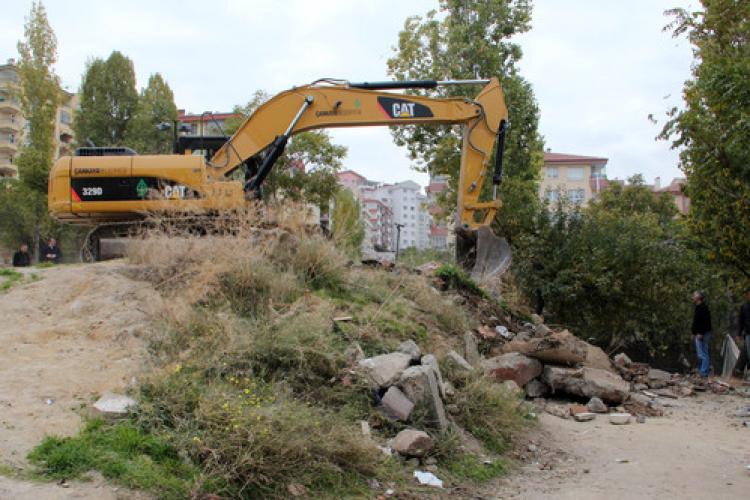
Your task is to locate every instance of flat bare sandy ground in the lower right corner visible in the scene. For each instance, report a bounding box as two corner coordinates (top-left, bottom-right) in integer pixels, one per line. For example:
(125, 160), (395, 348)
(493, 393), (750, 500)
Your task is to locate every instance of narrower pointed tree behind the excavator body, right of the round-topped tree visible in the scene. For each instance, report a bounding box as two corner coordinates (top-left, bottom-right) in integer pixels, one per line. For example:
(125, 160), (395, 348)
(125, 73), (177, 154)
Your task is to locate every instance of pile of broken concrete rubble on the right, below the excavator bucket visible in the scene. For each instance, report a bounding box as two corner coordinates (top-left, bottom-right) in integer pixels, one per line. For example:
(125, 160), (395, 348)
(465, 315), (744, 424)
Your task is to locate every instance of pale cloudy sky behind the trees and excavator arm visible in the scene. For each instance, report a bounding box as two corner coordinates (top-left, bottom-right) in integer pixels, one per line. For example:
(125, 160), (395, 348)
(0, 0), (696, 185)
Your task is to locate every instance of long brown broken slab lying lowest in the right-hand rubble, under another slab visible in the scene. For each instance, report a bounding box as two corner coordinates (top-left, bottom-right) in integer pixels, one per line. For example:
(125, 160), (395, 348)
(543, 365), (630, 403)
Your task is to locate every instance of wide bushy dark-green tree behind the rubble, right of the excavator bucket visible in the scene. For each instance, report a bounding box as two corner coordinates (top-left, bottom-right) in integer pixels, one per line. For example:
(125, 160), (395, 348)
(514, 181), (727, 368)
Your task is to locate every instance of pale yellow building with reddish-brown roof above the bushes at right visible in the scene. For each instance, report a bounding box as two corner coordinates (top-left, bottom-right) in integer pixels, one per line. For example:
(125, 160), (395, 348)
(539, 151), (608, 205)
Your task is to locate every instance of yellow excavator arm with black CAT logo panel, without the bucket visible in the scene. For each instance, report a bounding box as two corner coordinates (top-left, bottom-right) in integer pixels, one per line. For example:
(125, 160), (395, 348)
(207, 78), (508, 233)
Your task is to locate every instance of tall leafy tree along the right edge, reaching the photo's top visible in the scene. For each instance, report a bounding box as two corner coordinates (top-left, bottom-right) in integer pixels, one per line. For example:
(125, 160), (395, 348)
(660, 0), (750, 279)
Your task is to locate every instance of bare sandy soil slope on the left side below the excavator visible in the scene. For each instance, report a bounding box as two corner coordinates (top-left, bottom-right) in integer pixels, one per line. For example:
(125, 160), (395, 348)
(0, 261), (161, 498)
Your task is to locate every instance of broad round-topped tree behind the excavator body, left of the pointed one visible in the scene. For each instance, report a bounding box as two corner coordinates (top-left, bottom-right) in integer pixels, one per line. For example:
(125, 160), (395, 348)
(74, 51), (138, 146)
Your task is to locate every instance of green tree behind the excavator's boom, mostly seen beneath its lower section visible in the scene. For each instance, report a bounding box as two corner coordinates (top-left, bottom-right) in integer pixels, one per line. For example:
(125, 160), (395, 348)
(225, 90), (346, 210)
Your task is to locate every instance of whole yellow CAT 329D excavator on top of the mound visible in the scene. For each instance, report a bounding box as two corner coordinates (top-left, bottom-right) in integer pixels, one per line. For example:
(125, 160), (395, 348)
(48, 78), (510, 277)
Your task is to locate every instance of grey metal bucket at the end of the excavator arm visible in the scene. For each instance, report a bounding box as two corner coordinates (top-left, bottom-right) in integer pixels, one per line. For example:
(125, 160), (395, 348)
(456, 226), (512, 282)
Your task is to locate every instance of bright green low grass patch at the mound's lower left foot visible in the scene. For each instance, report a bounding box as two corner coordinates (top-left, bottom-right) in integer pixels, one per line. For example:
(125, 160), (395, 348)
(29, 419), (199, 498)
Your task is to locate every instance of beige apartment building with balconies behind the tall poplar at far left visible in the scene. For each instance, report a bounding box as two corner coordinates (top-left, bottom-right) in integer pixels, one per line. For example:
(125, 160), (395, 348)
(0, 59), (78, 177)
